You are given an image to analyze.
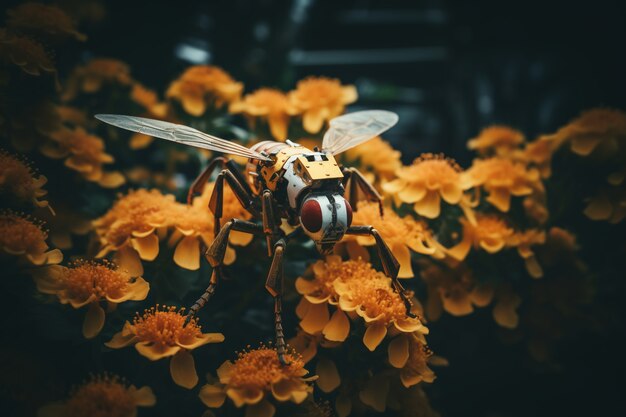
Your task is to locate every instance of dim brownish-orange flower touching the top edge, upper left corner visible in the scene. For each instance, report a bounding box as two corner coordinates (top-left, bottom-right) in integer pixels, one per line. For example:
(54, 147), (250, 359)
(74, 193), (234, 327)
(7, 2), (87, 41)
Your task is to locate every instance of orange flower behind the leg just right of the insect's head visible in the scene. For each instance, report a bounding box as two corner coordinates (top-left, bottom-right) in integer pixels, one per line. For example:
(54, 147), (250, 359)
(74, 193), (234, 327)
(343, 202), (445, 278)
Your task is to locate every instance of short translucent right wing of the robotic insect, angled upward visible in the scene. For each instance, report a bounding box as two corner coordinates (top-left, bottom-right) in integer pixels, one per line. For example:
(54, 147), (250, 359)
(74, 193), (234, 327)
(322, 110), (398, 155)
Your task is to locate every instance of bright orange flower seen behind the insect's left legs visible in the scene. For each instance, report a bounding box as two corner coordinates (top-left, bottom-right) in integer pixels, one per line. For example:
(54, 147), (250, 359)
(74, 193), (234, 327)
(170, 182), (253, 270)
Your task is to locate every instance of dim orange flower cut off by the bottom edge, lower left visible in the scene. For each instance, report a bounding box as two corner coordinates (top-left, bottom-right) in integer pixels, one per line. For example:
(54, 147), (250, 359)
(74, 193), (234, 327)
(37, 374), (156, 417)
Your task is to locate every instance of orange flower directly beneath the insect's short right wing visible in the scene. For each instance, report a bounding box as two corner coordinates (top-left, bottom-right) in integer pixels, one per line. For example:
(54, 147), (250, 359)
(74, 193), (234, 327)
(345, 136), (402, 179)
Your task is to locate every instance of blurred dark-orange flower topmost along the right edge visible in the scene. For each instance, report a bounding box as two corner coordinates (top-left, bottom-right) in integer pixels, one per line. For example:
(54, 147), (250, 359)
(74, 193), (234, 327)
(549, 108), (626, 157)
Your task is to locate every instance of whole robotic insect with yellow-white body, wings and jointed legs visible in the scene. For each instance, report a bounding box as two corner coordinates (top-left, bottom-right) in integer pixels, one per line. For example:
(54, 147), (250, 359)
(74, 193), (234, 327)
(96, 110), (414, 363)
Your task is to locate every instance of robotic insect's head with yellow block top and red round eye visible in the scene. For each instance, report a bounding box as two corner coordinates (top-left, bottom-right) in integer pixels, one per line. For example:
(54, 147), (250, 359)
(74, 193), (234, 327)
(294, 152), (352, 255)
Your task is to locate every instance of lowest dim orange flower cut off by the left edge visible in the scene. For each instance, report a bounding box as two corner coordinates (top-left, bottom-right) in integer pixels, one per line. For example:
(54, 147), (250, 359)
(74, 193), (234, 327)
(0, 211), (63, 266)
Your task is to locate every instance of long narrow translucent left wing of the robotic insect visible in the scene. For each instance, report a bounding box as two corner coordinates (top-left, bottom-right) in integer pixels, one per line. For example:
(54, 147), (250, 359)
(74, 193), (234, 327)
(96, 114), (271, 161)
